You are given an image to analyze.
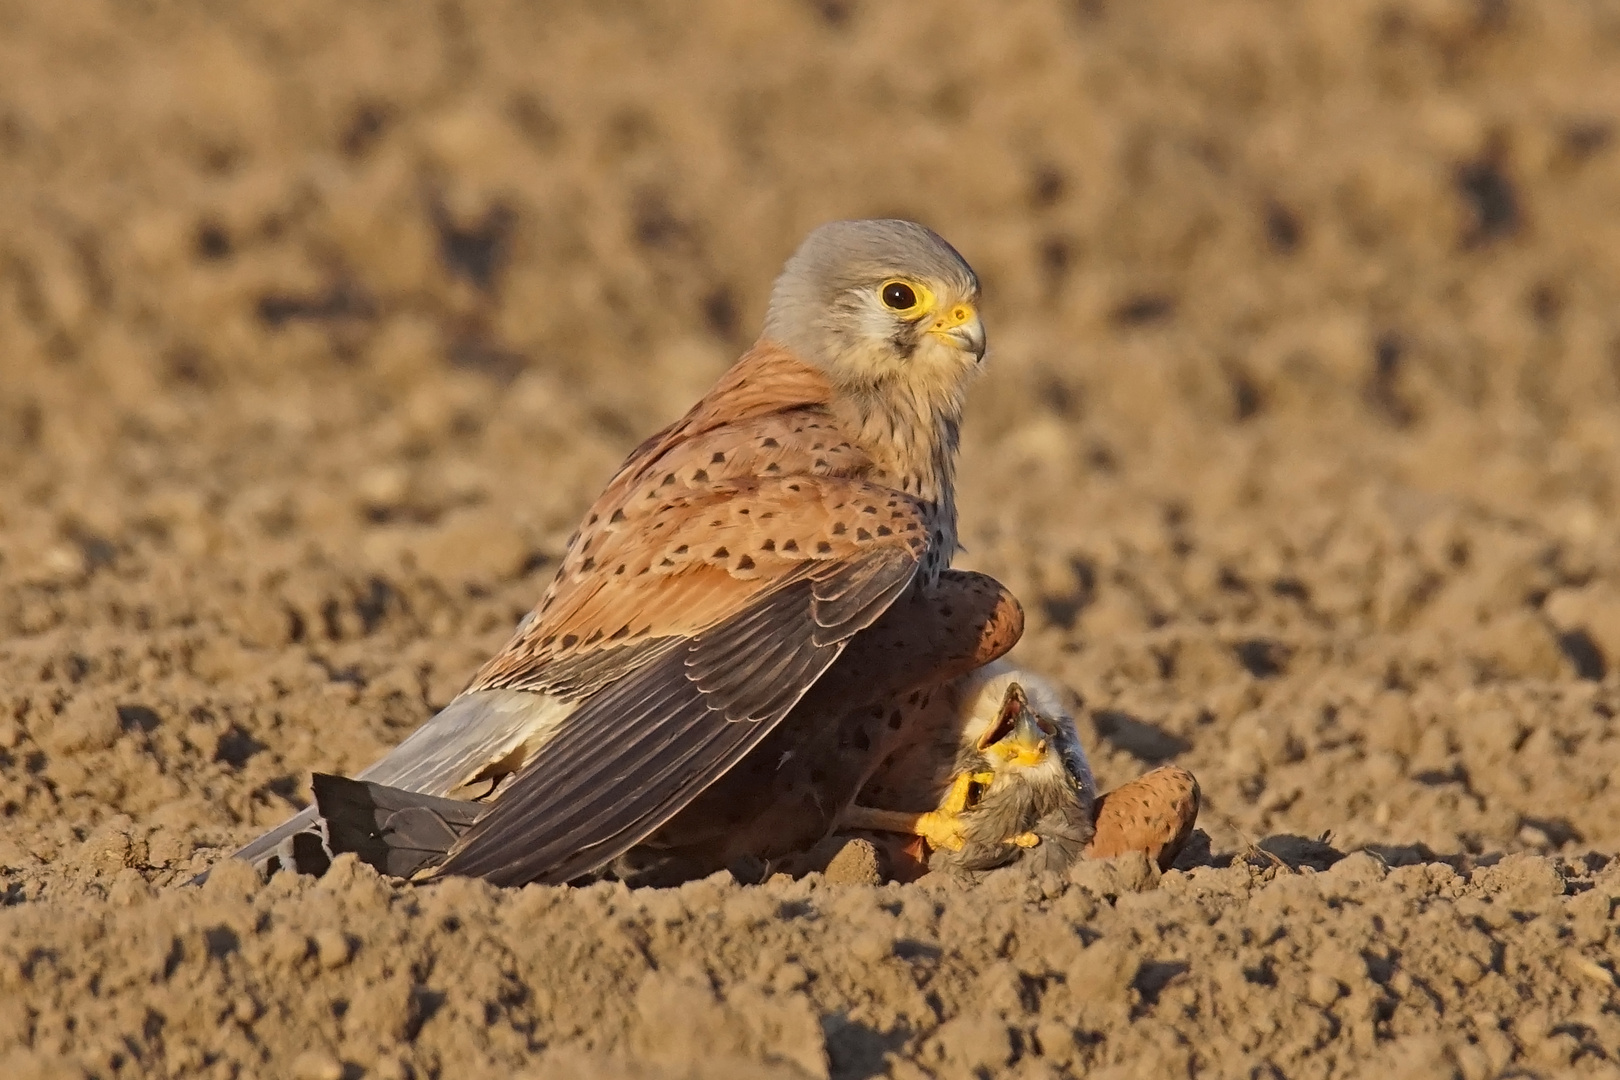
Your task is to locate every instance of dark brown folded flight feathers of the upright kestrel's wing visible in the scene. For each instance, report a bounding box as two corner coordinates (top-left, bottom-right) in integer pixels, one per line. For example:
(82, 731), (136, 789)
(441, 540), (917, 884)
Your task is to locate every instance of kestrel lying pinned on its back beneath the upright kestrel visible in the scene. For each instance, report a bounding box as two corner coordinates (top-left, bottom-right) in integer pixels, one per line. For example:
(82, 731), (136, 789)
(285, 647), (1200, 886)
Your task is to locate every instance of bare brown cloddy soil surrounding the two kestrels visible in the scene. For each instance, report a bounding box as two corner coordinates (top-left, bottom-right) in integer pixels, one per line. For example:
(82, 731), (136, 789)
(0, 0), (1620, 1080)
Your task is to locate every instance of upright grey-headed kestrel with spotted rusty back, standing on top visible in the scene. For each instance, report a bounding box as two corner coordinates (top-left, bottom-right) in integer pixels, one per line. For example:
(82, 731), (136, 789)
(208, 220), (985, 884)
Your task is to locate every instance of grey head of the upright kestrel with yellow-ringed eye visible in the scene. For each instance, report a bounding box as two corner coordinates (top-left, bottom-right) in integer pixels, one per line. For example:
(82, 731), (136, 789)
(763, 219), (985, 399)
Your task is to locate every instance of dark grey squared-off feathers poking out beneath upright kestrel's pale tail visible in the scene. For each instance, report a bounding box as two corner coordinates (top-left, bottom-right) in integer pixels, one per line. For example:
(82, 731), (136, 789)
(309, 772), (488, 878)
